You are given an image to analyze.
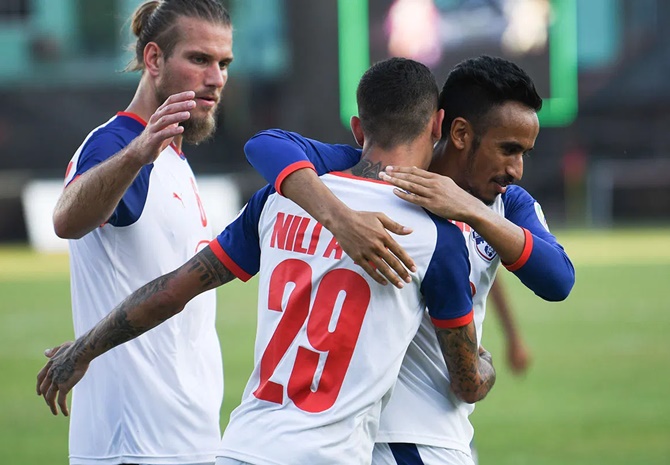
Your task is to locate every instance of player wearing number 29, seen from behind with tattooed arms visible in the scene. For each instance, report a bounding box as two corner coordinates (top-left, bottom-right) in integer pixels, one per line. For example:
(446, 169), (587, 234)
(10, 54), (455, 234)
(38, 58), (495, 465)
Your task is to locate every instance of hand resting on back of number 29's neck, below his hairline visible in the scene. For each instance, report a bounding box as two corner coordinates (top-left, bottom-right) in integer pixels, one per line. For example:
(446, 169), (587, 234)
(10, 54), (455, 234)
(379, 166), (484, 223)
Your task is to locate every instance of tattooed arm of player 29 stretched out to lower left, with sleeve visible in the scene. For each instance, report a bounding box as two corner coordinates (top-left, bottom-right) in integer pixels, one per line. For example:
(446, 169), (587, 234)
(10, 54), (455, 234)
(37, 184), (272, 415)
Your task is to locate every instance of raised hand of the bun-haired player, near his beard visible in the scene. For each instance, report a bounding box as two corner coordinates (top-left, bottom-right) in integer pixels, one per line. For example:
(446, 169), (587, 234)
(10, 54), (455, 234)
(128, 90), (196, 165)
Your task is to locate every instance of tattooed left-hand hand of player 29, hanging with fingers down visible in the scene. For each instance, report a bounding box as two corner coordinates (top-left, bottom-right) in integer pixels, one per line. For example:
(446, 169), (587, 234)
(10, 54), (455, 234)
(37, 342), (88, 416)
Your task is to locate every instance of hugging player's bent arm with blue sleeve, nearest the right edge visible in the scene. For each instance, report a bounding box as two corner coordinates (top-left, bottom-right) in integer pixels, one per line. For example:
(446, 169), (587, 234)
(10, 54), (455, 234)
(382, 167), (575, 301)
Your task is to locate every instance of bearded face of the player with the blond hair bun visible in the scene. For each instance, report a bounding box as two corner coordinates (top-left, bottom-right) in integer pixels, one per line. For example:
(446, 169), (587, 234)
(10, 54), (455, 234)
(156, 17), (233, 144)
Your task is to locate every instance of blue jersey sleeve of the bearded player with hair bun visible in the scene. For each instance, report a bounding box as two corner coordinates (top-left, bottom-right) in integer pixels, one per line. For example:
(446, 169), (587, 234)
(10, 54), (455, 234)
(66, 130), (153, 226)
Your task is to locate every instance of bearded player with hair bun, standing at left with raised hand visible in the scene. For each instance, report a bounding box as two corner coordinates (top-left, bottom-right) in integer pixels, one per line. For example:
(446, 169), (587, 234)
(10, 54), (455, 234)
(43, 0), (233, 465)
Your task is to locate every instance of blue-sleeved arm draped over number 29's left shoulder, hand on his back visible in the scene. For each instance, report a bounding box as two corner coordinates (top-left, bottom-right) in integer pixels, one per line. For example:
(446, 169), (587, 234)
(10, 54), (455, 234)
(244, 130), (415, 287)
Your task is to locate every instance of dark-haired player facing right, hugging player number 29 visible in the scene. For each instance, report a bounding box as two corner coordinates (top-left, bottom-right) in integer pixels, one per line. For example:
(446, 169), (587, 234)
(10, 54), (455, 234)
(245, 56), (575, 464)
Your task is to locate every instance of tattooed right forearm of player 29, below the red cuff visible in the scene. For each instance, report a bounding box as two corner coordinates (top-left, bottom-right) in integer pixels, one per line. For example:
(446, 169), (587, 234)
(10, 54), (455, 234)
(435, 321), (496, 404)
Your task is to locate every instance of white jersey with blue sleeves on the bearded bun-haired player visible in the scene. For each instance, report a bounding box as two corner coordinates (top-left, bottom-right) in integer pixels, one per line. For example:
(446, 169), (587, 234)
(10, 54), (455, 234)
(65, 113), (223, 465)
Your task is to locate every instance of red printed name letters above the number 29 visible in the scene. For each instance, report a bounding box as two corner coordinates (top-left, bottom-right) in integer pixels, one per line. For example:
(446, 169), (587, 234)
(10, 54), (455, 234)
(270, 212), (342, 260)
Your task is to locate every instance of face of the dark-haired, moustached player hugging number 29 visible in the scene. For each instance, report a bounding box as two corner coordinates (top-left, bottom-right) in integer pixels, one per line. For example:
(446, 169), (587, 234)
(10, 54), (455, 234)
(466, 102), (540, 205)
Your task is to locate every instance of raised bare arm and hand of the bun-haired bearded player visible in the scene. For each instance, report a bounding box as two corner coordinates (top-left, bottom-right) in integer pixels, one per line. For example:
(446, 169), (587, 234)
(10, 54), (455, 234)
(53, 91), (195, 239)
